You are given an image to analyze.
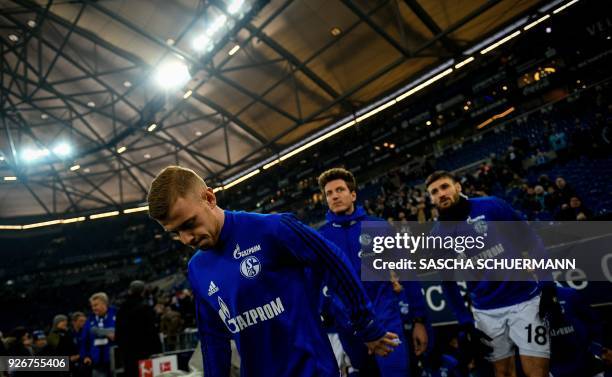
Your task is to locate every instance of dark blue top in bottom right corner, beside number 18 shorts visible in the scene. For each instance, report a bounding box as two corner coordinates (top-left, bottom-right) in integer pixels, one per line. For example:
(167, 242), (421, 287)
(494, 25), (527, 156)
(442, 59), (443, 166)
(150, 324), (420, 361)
(550, 288), (603, 377)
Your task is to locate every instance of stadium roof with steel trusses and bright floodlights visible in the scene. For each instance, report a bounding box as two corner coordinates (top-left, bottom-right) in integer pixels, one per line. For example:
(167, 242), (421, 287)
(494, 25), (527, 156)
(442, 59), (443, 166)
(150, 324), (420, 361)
(0, 0), (561, 219)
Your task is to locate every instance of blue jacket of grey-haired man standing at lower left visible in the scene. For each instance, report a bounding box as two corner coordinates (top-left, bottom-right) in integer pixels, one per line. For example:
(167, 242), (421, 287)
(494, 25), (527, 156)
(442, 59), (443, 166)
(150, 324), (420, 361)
(80, 306), (117, 365)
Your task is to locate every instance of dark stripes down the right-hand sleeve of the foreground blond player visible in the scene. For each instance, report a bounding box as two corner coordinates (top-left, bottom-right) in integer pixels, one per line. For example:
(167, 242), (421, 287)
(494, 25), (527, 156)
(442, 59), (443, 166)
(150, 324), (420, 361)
(281, 216), (371, 327)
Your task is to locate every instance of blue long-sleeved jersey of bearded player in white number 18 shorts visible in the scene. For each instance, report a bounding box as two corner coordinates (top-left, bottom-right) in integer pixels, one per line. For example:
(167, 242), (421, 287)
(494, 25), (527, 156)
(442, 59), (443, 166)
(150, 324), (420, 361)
(432, 197), (543, 312)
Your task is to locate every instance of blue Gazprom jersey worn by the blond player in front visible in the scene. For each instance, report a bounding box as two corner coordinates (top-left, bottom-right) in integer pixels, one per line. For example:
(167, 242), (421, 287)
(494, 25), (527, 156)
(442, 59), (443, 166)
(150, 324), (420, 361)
(189, 211), (385, 377)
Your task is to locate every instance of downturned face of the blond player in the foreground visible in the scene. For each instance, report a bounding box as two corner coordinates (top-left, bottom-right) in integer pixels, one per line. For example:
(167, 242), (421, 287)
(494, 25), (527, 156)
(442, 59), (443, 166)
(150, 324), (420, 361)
(162, 189), (221, 249)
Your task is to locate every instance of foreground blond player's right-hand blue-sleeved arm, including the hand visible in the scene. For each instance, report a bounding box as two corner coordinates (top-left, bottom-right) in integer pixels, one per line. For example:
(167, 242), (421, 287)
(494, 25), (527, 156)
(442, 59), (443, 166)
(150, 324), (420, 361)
(275, 214), (397, 351)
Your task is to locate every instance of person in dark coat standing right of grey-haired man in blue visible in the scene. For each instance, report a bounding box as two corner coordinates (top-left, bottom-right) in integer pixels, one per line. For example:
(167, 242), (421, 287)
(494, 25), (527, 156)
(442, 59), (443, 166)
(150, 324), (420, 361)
(115, 280), (162, 377)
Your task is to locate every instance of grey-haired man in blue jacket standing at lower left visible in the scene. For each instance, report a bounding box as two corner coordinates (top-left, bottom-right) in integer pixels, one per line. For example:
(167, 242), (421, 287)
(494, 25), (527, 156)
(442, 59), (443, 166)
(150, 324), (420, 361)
(81, 292), (116, 377)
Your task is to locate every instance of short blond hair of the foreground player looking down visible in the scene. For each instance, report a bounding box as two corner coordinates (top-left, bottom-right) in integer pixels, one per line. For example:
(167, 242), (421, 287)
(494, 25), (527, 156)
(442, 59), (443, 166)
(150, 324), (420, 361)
(147, 166), (207, 221)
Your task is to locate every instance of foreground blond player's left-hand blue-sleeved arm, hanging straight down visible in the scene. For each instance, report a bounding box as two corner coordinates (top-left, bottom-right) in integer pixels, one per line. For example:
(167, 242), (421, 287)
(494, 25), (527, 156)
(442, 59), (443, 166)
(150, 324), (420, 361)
(189, 270), (232, 377)
